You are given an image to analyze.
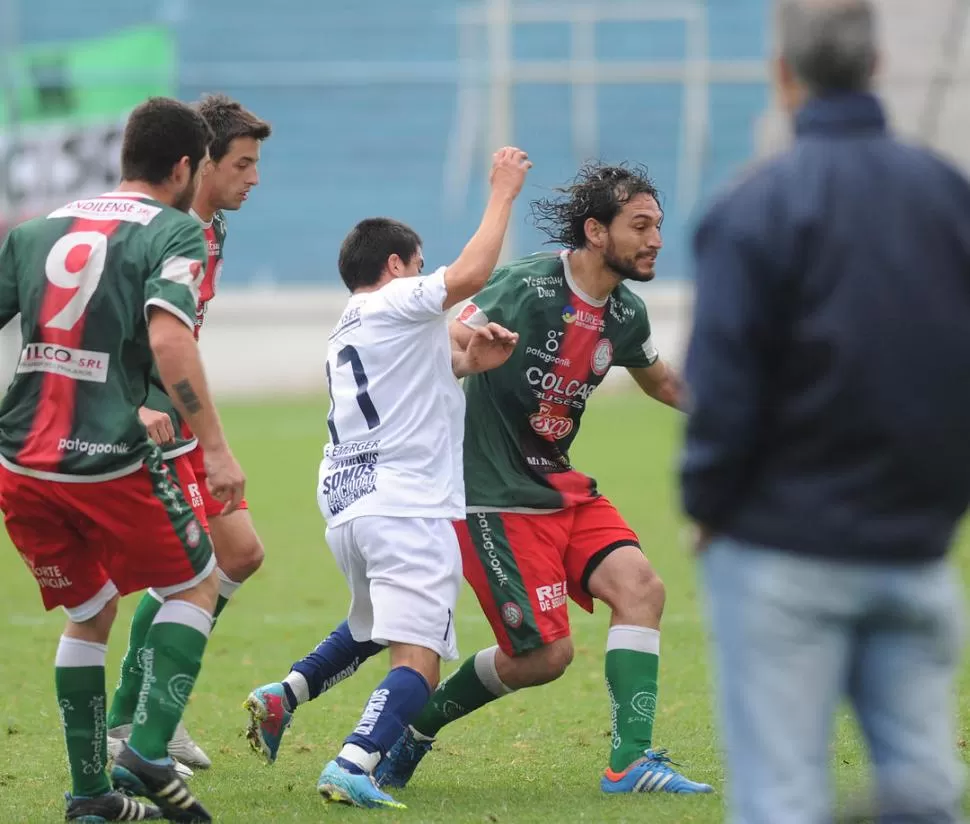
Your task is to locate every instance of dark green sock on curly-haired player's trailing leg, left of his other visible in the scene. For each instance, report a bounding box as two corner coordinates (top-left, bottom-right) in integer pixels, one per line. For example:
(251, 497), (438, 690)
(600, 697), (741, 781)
(411, 647), (512, 738)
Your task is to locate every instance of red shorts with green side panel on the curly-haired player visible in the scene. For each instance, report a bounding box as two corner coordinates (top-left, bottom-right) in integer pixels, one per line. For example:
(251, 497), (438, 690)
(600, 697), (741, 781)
(455, 497), (640, 655)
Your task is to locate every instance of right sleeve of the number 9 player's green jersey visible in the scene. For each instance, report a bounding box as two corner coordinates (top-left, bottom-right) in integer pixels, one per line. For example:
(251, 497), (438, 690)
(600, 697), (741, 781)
(145, 219), (206, 330)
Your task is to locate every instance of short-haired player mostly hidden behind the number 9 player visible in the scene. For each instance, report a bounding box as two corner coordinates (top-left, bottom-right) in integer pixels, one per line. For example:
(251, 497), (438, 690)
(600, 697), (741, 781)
(108, 95), (271, 774)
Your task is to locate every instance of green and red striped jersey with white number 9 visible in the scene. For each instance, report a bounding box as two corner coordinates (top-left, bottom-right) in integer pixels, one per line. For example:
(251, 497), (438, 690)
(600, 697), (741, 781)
(0, 192), (205, 482)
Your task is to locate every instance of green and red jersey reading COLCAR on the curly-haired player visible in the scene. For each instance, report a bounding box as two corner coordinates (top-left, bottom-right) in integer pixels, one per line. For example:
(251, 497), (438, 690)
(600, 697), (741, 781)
(458, 252), (658, 512)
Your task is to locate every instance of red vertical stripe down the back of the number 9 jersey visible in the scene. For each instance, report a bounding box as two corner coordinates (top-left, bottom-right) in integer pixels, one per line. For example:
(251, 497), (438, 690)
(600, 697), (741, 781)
(17, 219), (121, 472)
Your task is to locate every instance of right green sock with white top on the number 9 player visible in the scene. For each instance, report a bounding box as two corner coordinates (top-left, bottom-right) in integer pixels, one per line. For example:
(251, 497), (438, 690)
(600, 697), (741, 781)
(128, 599), (212, 760)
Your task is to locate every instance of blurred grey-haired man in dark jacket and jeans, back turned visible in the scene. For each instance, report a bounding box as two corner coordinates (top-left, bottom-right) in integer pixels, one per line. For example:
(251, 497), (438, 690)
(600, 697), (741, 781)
(682, 0), (970, 824)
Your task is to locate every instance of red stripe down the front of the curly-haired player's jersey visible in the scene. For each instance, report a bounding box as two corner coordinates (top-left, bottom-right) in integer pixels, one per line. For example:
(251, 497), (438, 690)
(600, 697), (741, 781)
(542, 294), (606, 506)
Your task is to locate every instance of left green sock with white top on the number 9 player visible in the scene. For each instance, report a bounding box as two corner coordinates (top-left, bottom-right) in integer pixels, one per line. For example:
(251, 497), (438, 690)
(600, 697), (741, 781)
(54, 636), (111, 797)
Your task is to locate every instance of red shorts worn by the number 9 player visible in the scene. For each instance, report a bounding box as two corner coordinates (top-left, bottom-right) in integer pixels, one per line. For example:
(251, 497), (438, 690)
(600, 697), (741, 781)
(0, 453), (215, 621)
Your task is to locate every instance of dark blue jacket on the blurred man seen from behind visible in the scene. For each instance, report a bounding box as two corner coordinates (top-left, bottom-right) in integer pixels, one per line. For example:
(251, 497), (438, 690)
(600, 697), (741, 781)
(682, 94), (970, 562)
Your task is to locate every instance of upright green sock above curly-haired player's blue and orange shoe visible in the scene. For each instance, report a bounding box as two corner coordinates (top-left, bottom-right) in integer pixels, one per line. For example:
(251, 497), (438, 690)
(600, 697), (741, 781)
(606, 625), (660, 772)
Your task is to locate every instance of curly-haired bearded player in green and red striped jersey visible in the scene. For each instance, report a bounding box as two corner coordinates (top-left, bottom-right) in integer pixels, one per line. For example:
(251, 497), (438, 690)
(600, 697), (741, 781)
(251, 165), (712, 793)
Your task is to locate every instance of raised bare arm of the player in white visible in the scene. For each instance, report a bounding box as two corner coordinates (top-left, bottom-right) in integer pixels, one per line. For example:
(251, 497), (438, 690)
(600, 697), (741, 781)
(444, 147), (532, 309)
